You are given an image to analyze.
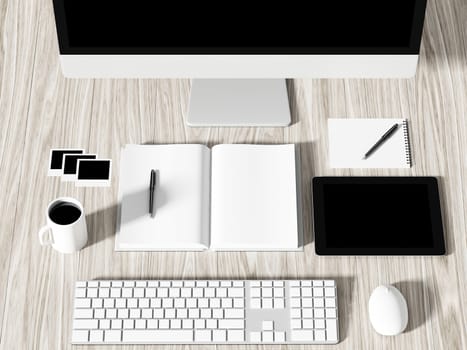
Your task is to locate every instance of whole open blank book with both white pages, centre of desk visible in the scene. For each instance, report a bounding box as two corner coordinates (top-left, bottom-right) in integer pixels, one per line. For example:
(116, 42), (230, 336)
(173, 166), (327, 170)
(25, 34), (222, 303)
(115, 144), (303, 251)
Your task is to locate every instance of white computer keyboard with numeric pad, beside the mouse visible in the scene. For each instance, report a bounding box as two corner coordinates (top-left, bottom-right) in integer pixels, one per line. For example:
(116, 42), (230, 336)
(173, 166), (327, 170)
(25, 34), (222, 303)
(72, 280), (339, 344)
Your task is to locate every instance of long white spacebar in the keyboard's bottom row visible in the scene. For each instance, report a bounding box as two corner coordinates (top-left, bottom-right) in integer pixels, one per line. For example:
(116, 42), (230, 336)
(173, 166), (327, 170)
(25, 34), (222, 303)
(122, 329), (193, 344)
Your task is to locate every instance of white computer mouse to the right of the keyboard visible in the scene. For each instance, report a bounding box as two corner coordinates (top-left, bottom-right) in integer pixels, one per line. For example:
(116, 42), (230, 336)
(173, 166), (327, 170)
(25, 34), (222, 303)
(368, 285), (409, 335)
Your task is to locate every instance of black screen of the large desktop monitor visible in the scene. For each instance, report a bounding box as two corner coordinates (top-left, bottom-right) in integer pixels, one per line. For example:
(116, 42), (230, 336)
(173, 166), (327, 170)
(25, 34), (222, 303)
(54, 0), (426, 54)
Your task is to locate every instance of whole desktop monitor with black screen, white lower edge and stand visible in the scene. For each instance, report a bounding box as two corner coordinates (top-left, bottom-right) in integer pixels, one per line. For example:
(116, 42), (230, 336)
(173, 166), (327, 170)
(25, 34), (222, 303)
(53, 0), (426, 126)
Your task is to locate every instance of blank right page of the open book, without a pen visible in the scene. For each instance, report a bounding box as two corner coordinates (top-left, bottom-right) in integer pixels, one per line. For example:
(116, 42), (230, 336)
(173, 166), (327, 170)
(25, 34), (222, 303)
(211, 145), (301, 250)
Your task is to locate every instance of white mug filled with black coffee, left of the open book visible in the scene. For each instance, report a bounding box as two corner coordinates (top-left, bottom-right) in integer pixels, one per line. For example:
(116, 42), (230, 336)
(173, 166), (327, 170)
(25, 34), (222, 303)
(39, 197), (88, 253)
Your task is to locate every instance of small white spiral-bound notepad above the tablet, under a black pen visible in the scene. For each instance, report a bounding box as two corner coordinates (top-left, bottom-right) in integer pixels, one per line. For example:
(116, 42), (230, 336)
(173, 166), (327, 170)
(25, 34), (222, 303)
(328, 118), (412, 168)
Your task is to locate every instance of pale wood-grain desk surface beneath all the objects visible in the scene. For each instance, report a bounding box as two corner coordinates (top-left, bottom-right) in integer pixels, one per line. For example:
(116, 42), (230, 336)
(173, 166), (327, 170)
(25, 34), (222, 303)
(0, 0), (467, 350)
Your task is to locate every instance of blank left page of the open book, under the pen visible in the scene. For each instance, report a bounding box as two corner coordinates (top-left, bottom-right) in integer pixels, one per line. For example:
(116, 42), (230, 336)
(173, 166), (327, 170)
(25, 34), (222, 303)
(115, 145), (210, 251)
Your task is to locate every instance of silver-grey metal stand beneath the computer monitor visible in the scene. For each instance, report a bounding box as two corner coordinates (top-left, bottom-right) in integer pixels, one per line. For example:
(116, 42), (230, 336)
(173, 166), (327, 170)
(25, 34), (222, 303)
(187, 79), (291, 127)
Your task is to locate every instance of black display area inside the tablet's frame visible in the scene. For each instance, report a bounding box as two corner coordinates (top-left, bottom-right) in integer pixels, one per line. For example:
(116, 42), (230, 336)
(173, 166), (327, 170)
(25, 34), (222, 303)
(323, 184), (433, 248)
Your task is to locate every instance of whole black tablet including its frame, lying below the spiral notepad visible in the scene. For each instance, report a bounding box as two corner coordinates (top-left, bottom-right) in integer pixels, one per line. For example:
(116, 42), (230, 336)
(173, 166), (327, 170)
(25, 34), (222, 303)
(313, 177), (445, 255)
